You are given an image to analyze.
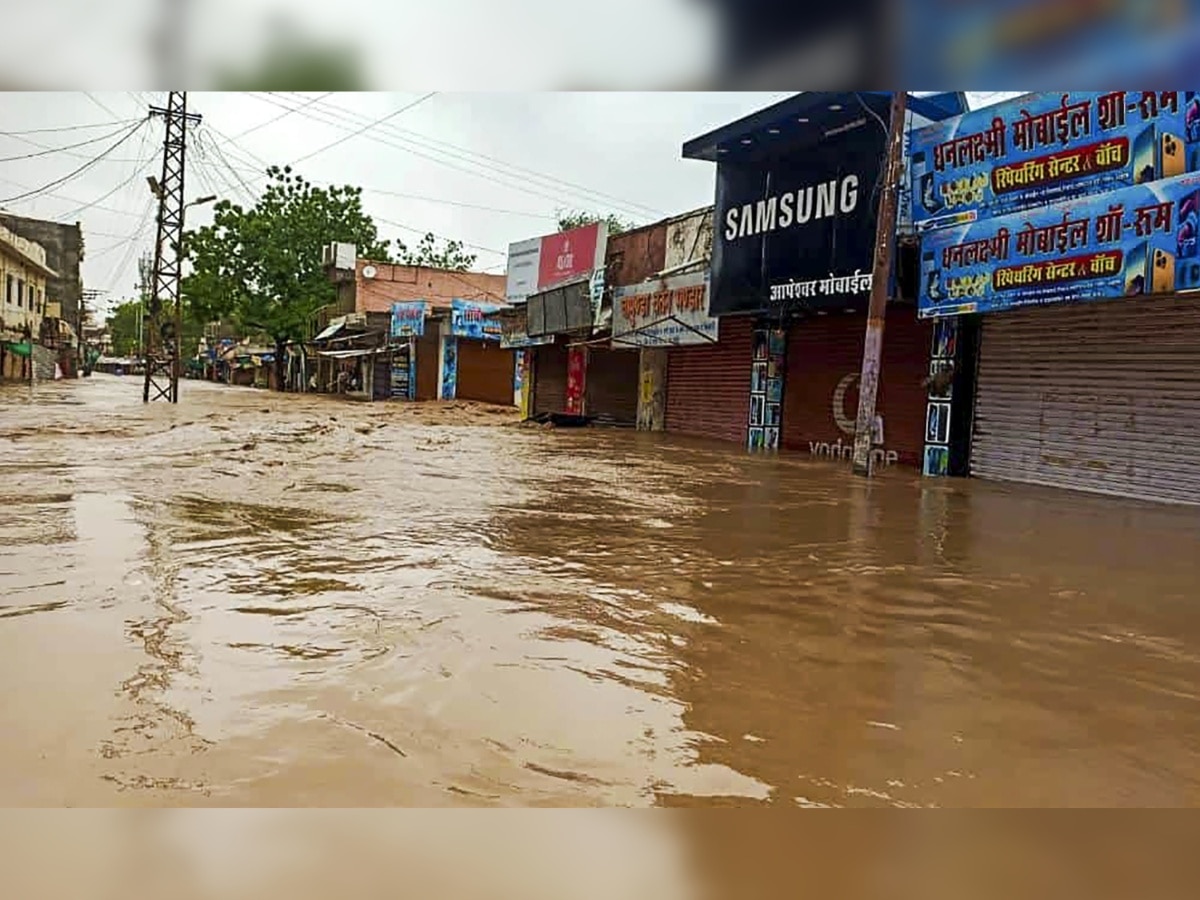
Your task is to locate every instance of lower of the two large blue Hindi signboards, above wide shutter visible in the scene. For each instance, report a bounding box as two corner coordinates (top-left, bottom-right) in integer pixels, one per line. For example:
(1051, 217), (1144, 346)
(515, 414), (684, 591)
(918, 174), (1200, 318)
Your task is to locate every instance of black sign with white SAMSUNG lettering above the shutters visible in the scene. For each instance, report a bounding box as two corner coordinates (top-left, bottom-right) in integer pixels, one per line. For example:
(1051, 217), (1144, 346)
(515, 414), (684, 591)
(709, 121), (887, 316)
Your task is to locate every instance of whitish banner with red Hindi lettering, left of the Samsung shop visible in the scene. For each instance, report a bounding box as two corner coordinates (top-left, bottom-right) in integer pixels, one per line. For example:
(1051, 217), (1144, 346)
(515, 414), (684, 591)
(612, 272), (718, 347)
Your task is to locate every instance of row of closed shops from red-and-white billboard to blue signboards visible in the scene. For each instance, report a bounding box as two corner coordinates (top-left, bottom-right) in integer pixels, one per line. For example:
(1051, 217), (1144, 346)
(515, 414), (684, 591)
(504, 91), (1200, 511)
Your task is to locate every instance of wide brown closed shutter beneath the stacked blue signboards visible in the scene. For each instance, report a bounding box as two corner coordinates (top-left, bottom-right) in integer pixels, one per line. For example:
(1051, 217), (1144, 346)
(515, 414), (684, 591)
(971, 298), (1200, 503)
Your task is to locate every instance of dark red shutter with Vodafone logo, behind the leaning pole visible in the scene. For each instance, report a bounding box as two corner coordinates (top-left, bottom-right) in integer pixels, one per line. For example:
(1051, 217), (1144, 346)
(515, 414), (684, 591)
(780, 306), (932, 466)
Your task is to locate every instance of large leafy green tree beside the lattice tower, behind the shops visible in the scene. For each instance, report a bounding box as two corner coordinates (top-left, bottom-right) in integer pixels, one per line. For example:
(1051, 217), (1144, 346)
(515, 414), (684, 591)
(182, 166), (391, 383)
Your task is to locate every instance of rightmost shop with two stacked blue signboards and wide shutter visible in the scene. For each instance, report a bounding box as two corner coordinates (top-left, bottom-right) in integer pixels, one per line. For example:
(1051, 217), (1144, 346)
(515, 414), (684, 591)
(912, 91), (1200, 504)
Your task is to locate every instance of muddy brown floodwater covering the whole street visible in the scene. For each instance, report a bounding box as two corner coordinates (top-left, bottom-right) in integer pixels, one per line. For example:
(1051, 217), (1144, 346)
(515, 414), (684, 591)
(0, 376), (1200, 806)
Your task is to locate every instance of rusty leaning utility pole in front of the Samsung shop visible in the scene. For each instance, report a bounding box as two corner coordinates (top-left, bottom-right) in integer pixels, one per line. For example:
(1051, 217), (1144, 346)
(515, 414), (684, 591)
(854, 91), (908, 476)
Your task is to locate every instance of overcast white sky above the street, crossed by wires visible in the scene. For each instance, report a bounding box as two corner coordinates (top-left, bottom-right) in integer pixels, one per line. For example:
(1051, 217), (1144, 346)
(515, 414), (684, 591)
(0, 91), (1017, 319)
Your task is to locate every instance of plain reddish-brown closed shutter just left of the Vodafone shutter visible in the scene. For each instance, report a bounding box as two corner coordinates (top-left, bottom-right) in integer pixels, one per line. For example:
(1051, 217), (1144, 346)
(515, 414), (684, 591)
(666, 317), (754, 443)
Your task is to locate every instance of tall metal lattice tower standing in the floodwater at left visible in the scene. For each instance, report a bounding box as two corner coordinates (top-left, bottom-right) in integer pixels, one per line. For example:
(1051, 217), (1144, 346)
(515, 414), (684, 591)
(142, 91), (200, 403)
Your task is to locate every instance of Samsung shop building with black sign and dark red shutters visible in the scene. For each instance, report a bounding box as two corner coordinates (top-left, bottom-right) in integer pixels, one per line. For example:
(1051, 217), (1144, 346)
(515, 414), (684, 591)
(666, 91), (965, 466)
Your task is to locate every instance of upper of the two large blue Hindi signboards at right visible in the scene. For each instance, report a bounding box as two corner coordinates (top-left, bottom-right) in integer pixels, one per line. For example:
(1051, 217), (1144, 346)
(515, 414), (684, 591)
(911, 91), (1200, 230)
